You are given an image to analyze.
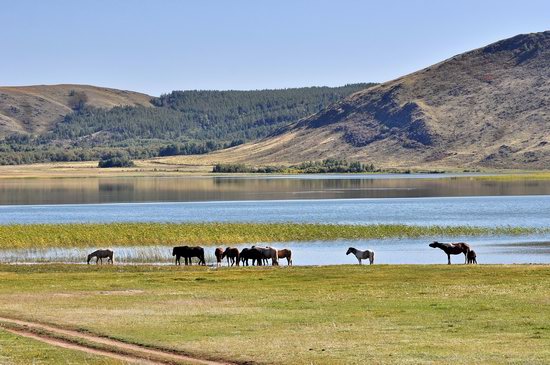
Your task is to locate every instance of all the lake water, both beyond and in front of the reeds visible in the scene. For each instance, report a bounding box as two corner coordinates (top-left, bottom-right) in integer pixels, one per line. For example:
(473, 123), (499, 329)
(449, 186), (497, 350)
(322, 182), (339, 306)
(0, 174), (550, 265)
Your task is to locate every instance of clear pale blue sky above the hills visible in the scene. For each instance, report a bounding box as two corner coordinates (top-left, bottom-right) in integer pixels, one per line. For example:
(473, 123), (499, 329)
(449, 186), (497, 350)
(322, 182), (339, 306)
(0, 0), (550, 95)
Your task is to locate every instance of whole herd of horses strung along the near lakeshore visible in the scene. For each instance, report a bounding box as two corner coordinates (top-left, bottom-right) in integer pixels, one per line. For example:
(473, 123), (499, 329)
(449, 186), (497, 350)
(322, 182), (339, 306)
(87, 241), (477, 267)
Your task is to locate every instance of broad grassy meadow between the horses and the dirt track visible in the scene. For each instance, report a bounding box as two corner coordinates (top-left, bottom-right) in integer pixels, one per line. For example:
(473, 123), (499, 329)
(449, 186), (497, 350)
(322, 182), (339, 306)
(0, 265), (550, 364)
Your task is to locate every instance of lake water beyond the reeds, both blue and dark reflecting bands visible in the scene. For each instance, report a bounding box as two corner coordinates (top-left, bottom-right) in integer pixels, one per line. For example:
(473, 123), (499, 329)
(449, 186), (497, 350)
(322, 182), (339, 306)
(0, 174), (550, 227)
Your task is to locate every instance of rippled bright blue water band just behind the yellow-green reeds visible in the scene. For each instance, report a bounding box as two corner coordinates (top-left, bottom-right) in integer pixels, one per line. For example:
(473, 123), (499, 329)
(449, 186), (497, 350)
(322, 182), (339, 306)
(0, 195), (550, 227)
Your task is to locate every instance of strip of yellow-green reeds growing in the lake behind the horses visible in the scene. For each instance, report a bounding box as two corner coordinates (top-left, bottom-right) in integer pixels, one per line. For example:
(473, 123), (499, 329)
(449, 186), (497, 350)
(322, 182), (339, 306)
(0, 223), (550, 248)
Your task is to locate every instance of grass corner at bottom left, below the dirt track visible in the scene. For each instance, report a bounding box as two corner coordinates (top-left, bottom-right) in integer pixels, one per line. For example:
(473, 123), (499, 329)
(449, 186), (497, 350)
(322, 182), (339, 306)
(0, 329), (124, 365)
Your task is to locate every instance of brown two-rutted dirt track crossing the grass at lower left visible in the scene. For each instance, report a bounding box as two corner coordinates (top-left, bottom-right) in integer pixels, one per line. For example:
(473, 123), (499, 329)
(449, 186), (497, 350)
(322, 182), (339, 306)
(0, 316), (238, 365)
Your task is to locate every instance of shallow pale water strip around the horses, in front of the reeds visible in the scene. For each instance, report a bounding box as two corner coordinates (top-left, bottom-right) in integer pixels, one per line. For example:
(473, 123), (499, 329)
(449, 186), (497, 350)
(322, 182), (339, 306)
(0, 235), (550, 265)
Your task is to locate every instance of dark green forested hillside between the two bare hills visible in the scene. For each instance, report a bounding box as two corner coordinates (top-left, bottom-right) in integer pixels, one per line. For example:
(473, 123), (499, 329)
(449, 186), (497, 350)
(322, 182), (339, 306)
(0, 84), (372, 164)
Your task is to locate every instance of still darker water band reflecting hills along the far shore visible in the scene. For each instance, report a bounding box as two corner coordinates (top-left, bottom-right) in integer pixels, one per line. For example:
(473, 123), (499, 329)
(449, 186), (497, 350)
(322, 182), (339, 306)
(0, 174), (550, 205)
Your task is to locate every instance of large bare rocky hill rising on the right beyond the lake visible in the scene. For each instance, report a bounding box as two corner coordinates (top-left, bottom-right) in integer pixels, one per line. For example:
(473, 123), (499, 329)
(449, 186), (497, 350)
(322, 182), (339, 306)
(183, 31), (550, 169)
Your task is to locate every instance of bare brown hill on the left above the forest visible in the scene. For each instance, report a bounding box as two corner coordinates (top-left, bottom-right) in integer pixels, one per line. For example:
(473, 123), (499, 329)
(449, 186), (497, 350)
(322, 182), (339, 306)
(0, 85), (151, 136)
